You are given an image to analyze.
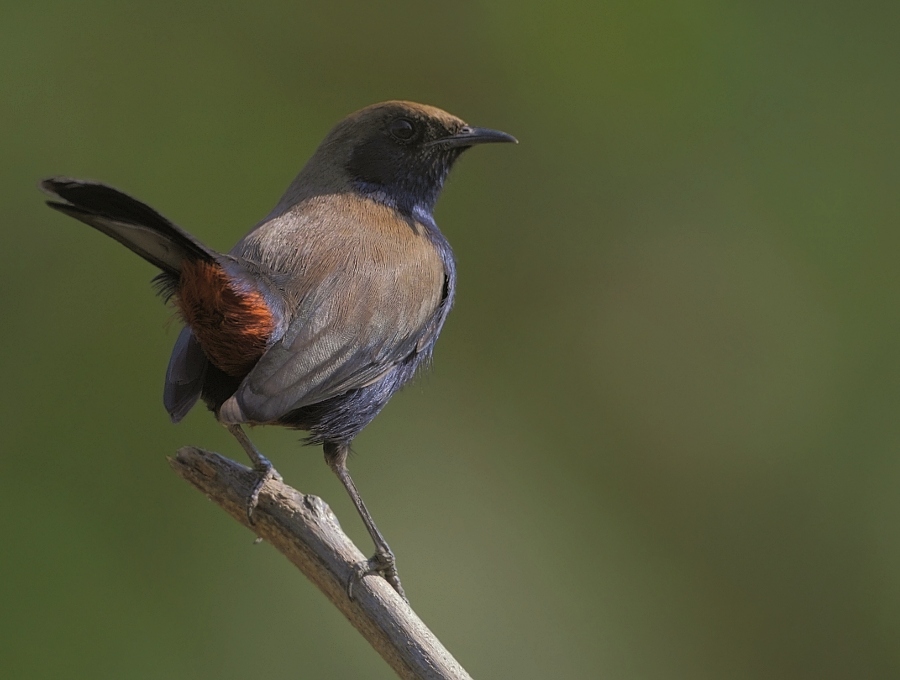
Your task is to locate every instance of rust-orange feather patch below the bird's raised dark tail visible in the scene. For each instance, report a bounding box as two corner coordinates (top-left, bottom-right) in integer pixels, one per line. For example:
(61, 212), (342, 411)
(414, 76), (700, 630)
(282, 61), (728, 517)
(175, 262), (275, 377)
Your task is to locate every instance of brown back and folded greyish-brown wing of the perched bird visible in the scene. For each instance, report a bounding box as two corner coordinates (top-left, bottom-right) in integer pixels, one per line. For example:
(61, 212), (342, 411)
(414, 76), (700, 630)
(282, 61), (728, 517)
(219, 193), (446, 423)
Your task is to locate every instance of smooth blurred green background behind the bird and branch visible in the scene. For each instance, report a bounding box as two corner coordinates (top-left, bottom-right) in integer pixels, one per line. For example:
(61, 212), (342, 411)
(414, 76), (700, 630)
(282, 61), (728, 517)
(0, 0), (900, 680)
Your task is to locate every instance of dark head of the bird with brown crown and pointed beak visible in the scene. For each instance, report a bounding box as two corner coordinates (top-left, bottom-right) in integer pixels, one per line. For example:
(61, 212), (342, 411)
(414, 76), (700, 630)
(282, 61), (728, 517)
(311, 101), (516, 212)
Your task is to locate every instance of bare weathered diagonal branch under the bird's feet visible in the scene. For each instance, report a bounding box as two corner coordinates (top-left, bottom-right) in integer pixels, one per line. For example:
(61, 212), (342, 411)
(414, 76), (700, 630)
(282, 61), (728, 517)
(169, 447), (471, 680)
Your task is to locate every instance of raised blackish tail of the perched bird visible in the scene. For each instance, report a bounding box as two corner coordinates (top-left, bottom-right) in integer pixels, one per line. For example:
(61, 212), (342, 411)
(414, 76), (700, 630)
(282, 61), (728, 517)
(41, 177), (216, 280)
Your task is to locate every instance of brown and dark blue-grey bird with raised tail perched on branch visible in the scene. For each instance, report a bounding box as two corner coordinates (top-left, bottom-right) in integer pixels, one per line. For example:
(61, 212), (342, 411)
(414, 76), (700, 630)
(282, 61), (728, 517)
(41, 101), (517, 599)
